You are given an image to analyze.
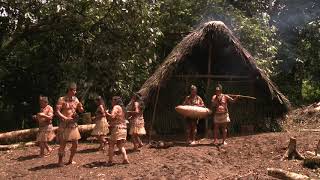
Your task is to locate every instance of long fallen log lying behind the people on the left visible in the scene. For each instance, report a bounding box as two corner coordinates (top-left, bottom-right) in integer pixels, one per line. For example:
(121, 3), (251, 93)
(0, 124), (94, 144)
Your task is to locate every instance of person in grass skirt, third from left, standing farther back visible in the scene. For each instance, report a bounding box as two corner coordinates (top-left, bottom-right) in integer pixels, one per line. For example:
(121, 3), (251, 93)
(91, 96), (109, 150)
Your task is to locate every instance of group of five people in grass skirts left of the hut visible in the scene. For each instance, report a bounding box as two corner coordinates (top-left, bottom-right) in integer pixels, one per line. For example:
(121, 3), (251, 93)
(34, 83), (146, 166)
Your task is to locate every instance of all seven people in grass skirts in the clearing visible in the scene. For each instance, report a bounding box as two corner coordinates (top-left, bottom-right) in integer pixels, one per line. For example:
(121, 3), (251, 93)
(34, 83), (239, 166)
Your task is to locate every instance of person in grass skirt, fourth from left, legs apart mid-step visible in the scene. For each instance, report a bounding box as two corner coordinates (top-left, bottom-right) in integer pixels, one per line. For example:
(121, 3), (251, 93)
(106, 96), (129, 165)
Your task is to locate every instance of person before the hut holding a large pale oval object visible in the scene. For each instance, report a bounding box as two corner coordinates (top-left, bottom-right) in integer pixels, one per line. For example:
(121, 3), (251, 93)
(183, 85), (204, 145)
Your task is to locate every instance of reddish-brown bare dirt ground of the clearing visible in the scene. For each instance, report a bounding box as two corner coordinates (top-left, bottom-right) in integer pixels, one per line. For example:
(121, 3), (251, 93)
(0, 132), (320, 179)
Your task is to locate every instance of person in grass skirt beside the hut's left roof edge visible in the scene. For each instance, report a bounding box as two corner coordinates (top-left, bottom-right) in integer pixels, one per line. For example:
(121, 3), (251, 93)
(127, 93), (146, 150)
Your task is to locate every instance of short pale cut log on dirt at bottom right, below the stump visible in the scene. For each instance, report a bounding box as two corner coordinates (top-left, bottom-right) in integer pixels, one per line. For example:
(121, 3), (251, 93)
(267, 168), (310, 180)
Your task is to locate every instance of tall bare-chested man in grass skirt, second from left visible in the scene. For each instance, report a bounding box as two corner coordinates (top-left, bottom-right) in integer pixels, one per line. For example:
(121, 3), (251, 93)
(56, 83), (84, 166)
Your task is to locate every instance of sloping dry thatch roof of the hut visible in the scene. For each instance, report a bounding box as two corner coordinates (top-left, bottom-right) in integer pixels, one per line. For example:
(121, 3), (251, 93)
(139, 21), (290, 108)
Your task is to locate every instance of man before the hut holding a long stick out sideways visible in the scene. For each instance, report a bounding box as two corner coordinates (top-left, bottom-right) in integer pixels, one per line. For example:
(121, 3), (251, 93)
(211, 84), (239, 145)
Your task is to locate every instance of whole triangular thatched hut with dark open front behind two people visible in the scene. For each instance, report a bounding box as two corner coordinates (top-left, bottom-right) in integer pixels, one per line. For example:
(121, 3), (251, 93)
(139, 21), (289, 134)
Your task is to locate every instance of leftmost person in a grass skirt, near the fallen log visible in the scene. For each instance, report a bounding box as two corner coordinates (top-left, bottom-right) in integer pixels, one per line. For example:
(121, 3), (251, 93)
(33, 96), (55, 157)
